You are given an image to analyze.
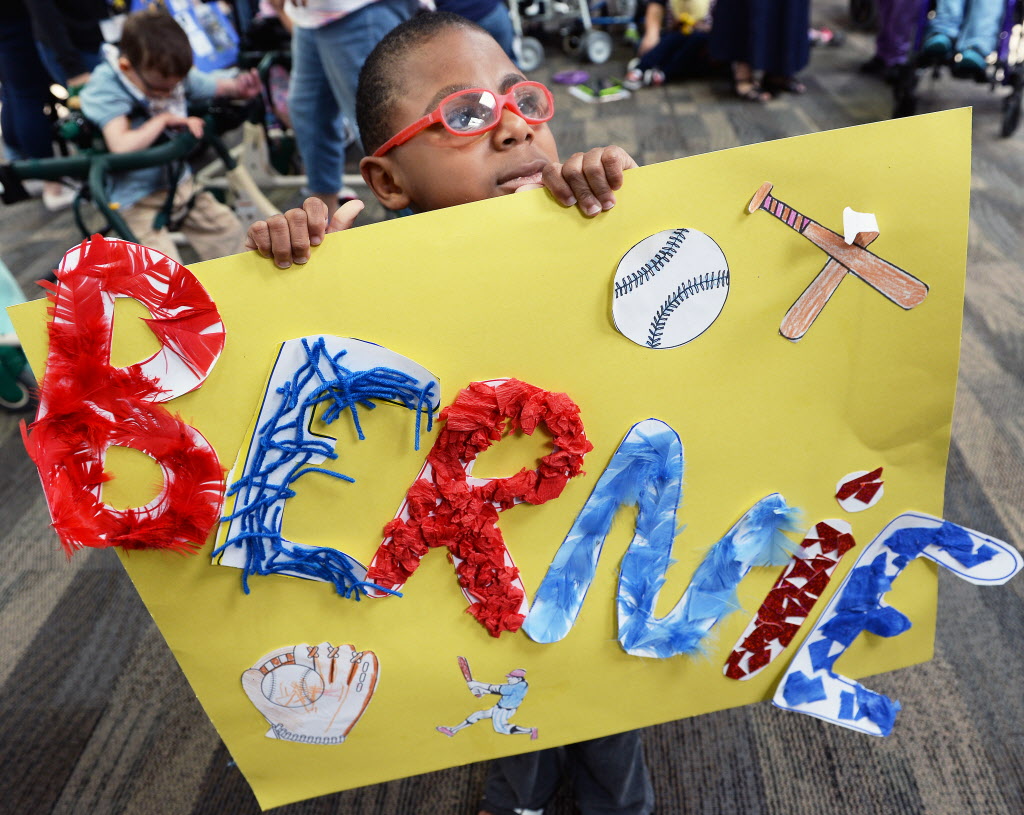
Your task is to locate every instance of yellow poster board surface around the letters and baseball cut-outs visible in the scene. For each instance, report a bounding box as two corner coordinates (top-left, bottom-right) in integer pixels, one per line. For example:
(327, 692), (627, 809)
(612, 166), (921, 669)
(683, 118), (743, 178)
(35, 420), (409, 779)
(13, 111), (971, 807)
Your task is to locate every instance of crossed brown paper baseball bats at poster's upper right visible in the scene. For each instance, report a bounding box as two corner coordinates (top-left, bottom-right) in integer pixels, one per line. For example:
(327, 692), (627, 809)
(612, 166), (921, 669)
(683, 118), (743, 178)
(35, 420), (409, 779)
(746, 183), (928, 340)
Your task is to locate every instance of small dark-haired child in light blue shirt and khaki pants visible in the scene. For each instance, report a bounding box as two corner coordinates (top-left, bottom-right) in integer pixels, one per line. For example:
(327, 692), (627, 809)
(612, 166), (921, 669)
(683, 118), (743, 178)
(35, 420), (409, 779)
(80, 10), (259, 260)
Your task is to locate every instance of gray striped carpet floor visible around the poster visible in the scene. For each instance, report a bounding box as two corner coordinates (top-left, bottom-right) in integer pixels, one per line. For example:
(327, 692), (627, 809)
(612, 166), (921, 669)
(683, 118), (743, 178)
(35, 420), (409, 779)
(0, 0), (1024, 815)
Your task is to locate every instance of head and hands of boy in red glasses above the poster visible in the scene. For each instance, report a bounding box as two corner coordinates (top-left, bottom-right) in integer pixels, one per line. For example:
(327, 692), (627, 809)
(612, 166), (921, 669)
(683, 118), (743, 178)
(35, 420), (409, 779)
(246, 12), (637, 268)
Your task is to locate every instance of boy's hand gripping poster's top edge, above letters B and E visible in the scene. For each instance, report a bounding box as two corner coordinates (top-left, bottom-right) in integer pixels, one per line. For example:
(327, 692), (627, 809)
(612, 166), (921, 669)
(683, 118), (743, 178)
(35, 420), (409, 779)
(246, 198), (364, 269)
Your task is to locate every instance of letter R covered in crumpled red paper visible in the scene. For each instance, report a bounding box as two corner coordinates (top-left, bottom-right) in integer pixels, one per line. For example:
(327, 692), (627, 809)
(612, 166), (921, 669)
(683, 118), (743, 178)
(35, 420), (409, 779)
(367, 379), (593, 637)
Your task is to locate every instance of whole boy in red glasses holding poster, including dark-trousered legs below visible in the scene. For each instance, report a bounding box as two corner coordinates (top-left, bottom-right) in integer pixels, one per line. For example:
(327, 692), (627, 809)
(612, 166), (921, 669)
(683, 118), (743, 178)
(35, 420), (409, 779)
(247, 12), (654, 815)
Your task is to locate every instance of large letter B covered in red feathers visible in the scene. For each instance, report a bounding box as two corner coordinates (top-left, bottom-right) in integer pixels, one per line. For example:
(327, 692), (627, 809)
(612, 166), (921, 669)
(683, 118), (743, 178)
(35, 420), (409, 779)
(22, 235), (224, 556)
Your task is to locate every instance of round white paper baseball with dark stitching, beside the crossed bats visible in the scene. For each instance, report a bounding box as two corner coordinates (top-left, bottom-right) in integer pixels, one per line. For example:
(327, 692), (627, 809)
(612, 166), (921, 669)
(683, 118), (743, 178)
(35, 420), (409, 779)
(611, 229), (729, 349)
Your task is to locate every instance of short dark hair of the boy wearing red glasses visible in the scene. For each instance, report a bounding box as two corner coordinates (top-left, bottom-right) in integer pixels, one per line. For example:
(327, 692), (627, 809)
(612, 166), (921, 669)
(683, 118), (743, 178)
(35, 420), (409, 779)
(355, 11), (490, 156)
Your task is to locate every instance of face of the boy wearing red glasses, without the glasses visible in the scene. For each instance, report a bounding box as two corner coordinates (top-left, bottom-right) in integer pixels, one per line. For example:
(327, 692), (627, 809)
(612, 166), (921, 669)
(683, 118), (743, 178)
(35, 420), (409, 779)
(362, 29), (558, 212)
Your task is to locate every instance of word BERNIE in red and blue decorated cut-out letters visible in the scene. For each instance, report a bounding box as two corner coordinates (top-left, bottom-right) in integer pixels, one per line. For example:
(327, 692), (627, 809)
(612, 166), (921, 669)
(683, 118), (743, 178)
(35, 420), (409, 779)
(23, 238), (1022, 735)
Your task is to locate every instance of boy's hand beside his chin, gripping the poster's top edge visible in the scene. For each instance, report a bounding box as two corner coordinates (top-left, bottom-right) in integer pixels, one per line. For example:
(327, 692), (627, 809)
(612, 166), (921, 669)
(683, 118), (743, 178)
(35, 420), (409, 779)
(543, 144), (637, 217)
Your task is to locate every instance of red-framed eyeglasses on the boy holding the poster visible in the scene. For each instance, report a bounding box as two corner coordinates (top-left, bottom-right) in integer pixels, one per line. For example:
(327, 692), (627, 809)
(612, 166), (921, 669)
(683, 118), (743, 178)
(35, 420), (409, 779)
(374, 82), (555, 158)
